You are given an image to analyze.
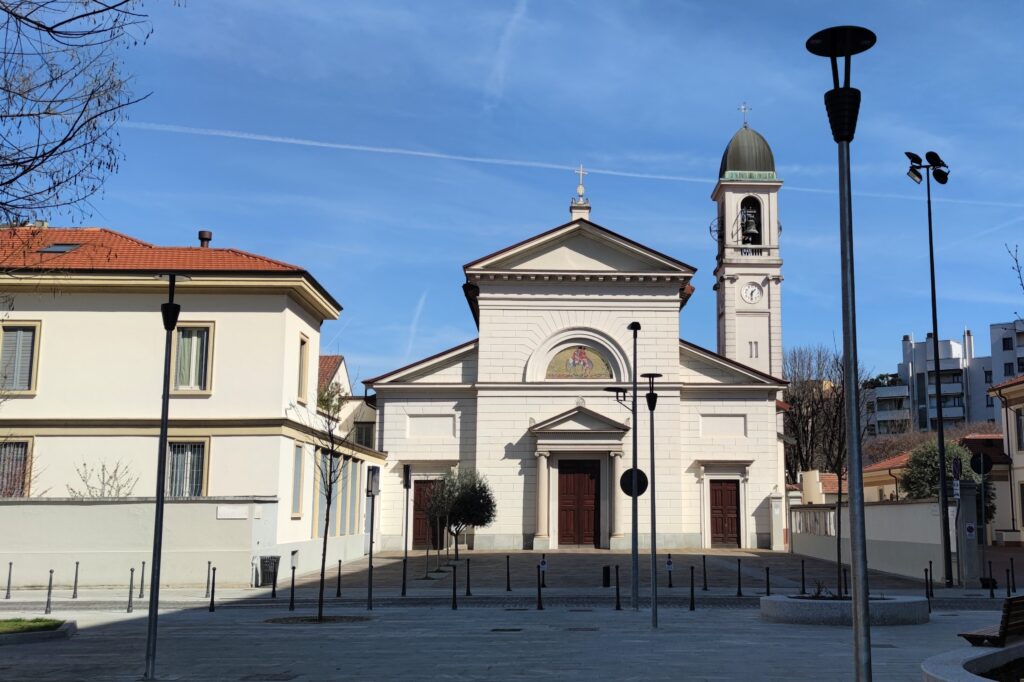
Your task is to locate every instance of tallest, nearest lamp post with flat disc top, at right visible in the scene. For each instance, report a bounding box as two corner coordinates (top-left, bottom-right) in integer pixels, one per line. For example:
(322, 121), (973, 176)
(807, 26), (876, 681)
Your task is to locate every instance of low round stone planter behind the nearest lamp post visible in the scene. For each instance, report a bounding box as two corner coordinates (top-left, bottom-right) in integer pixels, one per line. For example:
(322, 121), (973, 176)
(761, 595), (929, 626)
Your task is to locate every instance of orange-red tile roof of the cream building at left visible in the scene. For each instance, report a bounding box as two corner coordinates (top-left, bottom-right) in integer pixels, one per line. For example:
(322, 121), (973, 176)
(0, 226), (305, 273)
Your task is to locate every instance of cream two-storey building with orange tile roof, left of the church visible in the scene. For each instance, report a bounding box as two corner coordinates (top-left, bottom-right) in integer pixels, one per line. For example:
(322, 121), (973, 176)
(0, 225), (383, 585)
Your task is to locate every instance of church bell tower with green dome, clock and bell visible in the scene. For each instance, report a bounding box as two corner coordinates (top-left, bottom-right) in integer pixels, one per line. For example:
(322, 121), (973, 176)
(711, 122), (782, 377)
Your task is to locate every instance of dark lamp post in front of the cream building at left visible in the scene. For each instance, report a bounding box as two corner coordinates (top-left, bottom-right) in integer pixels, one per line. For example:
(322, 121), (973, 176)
(142, 274), (181, 680)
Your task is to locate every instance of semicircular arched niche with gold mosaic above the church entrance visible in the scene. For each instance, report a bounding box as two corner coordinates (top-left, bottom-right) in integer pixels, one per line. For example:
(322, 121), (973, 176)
(523, 328), (627, 383)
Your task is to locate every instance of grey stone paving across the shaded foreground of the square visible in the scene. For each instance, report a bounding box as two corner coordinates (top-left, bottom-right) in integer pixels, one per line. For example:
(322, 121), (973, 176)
(0, 608), (993, 682)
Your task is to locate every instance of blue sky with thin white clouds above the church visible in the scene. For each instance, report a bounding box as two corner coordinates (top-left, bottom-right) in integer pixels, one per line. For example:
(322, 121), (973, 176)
(77, 0), (1024, 378)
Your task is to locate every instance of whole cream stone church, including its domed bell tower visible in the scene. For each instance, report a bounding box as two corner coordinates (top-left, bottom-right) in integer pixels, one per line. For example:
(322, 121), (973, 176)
(366, 125), (786, 550)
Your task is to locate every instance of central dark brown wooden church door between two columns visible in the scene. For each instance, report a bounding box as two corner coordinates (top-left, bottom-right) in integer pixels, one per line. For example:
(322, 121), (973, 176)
(558, 460), (601, 547)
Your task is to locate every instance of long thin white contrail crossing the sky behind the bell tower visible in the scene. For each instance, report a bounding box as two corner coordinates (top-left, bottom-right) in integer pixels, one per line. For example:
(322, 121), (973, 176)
(120, 121), (1024, 208)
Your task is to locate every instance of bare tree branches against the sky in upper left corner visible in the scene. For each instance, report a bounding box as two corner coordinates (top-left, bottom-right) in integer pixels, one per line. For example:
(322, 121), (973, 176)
(0, 0), (151, 223)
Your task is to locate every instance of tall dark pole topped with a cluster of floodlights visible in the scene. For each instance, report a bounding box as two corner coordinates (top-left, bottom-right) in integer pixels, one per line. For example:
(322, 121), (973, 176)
(904, 152), (953, 588)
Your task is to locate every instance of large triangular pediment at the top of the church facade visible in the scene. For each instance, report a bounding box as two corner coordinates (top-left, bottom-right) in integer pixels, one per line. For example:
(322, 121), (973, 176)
(465, 219), (695, 275)
